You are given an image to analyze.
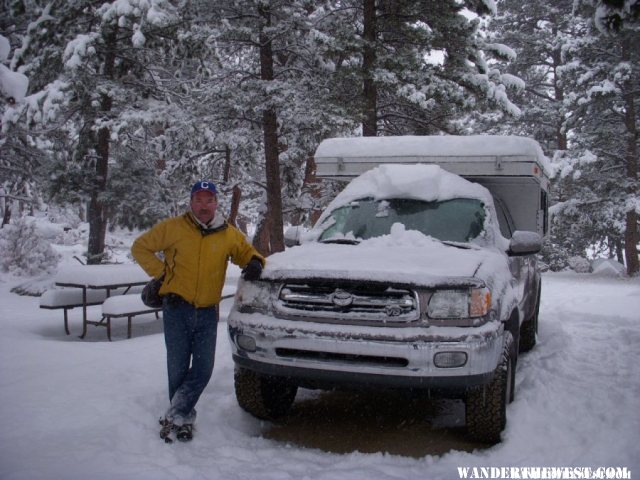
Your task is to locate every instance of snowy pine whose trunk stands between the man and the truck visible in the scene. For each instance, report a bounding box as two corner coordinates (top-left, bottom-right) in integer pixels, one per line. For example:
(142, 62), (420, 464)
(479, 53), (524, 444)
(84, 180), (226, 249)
(179, 0), (356, 254)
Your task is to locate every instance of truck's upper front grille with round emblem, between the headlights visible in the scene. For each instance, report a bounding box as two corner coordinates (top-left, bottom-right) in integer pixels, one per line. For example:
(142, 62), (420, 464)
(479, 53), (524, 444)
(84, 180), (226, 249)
(277, 283), (420, 325)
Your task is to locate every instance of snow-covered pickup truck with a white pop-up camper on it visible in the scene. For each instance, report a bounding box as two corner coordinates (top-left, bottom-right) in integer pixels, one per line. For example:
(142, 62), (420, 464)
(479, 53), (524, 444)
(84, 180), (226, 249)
(228, 136), (549, 443)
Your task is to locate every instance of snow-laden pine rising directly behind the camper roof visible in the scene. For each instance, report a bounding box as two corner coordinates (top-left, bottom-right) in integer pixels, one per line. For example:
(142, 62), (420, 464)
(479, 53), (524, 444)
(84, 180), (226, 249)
(320, 0), (520, 135)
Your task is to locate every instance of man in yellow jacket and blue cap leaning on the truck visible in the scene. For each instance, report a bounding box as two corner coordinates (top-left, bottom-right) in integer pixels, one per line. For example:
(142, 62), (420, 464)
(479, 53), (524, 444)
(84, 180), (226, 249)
(131, 181), (265, 443)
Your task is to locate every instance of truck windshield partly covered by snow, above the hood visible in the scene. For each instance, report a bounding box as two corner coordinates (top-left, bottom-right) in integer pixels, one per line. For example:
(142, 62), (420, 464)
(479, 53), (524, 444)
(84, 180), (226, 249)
(318, 198), (485, 243)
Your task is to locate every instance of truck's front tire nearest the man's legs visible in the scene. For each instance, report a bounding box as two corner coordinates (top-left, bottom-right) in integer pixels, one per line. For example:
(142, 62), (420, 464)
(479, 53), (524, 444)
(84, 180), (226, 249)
(234, 367), (298, 420)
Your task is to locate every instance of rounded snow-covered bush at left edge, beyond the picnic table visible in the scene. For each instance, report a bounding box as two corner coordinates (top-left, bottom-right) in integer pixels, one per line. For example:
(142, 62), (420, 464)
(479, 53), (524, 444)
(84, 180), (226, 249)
(0, 218), (60, 276)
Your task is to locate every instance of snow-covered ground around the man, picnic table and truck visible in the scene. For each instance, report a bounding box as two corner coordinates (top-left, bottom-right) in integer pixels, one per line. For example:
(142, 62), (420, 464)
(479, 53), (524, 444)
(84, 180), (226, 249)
(0, 253), (640, 480)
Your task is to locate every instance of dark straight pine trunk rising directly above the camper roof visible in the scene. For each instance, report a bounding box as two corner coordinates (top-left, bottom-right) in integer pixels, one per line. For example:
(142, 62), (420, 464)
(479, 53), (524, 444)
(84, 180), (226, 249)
(362, 0), (378, 137)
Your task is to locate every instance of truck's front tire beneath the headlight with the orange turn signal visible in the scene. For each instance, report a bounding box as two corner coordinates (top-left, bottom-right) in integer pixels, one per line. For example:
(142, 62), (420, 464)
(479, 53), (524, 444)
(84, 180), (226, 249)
(465, 332), (514, 444)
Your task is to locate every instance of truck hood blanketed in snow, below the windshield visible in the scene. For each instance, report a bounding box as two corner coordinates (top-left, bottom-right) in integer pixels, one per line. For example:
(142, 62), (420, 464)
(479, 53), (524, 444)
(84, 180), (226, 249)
(262, 225), (509, 287)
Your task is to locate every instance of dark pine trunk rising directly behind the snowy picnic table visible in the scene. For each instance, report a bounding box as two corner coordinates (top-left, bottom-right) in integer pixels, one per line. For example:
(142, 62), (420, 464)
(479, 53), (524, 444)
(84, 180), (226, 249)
(87, 27), (118, 265)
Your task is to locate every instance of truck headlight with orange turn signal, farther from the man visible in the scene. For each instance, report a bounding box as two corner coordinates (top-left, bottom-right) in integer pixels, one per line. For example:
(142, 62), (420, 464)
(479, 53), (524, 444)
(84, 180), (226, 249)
(427, 288), (491, 318)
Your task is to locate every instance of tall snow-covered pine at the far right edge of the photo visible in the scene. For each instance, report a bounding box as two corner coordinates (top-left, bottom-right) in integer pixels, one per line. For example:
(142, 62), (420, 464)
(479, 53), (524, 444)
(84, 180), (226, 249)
(563, 2), (640, 275)
